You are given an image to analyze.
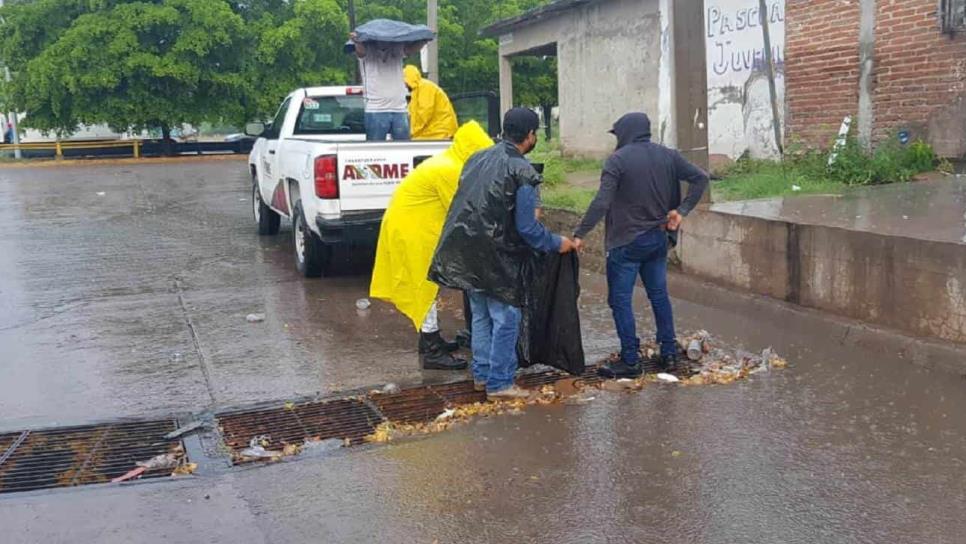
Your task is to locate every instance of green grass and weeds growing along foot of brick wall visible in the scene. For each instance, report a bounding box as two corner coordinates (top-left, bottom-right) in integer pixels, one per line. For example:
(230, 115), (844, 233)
(713, 138), (936, 202)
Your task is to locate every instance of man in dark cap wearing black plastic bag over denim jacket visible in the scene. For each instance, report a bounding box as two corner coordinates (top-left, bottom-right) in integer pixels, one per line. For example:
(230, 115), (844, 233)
(429, 108), (575, 399)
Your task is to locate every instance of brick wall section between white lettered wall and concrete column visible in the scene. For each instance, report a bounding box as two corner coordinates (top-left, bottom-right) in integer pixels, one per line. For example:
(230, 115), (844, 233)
(785, 0), (859, 146)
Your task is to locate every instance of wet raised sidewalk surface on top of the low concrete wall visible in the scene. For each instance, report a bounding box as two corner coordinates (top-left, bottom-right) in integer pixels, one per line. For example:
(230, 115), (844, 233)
(711, 176), (966, 244)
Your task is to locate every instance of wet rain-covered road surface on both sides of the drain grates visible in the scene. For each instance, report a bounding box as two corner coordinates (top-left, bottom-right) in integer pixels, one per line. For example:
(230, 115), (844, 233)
(0, 161), (966, 543)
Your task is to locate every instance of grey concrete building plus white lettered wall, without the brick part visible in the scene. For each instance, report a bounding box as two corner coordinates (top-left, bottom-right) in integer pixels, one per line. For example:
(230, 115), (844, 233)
(484, 0), (785, 162)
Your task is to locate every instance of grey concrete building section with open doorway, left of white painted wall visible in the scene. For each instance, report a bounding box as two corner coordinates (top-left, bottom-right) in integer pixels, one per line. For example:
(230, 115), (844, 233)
(485, 0), (670, 155)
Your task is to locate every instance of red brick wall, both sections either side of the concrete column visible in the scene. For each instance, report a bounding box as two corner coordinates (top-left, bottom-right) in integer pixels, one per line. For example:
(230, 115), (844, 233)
(785, 0), (966, 157)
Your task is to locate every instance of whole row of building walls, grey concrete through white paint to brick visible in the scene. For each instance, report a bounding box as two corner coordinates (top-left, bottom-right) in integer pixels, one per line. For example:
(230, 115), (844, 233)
(486, 0), (966, 159)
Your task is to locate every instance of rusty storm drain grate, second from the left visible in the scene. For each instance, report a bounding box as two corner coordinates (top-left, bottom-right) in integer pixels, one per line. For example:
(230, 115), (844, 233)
(218, 398), (382, 451)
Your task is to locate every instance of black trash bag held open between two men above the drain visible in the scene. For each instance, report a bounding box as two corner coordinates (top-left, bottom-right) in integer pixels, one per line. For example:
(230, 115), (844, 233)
(517, 252), (585, 375)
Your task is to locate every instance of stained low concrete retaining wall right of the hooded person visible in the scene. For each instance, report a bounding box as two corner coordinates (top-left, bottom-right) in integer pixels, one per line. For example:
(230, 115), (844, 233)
(679, 211), (966, 343)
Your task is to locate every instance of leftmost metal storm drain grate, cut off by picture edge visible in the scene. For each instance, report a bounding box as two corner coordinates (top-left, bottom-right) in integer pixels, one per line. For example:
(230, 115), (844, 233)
(0, 420), (184, 493)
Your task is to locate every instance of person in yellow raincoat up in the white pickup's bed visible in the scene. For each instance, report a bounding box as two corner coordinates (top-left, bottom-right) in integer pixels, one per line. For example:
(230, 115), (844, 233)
(403, 64), (456, 140)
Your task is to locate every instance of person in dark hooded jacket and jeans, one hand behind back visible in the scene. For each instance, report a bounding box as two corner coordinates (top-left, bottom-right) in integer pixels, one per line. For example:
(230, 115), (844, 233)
(574, 113), (708, 378)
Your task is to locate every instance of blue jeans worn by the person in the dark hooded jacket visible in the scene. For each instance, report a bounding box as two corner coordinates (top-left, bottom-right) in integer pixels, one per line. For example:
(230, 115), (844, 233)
(607, 229), (677, 364)
